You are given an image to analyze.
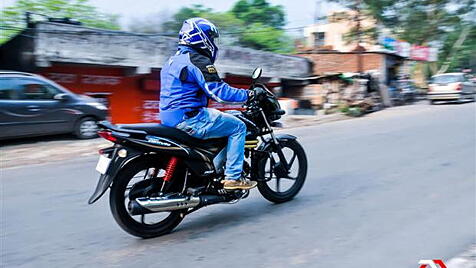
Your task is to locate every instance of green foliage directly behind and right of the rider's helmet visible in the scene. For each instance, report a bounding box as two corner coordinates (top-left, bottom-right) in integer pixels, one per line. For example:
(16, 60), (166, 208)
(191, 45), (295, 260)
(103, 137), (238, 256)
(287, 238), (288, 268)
(162, 0), (293, 53)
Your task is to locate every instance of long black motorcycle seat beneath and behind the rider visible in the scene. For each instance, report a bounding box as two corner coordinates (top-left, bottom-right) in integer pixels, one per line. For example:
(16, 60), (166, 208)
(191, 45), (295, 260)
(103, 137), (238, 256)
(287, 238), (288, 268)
(117, 123), (228, 149)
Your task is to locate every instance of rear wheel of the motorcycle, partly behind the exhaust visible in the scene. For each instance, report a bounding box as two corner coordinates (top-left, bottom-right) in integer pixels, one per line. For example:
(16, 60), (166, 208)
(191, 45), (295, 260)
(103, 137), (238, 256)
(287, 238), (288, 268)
(109, 160), (185, 238)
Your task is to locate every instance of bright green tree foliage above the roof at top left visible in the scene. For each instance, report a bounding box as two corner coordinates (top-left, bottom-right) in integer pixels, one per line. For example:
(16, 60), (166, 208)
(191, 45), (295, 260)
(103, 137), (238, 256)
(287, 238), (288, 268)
(0, 0), (120, 43)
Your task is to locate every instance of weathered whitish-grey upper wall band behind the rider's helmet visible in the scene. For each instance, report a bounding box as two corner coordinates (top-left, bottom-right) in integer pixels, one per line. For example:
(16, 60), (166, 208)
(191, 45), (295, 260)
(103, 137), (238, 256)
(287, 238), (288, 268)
(34, 23), (310, 78)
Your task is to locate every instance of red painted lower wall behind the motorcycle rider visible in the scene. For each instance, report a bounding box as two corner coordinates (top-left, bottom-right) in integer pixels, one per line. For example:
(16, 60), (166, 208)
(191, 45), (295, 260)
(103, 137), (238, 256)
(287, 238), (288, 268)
(38, 65), (255, 123)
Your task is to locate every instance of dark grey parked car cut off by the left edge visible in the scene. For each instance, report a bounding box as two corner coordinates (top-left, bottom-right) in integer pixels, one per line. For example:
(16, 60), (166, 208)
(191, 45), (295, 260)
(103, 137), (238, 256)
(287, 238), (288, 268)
(0, 71), (107, 140)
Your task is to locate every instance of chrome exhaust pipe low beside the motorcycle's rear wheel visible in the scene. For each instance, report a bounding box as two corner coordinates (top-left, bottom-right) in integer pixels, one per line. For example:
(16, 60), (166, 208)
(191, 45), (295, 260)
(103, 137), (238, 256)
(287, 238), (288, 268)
(128, 195), (200, 215)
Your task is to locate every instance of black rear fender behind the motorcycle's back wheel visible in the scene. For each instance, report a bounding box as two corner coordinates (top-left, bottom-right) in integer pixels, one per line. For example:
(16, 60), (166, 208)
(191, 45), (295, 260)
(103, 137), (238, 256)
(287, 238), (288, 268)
(88, 147), (143, 204)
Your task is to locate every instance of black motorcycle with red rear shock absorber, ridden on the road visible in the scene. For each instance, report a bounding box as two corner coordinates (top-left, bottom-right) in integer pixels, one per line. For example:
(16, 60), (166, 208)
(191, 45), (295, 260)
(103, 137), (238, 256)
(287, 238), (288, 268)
(89, 68), (307, 238)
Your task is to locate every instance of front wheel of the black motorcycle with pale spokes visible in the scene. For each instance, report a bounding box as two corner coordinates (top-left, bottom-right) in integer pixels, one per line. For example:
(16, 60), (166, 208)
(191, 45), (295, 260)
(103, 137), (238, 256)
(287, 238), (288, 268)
(258, 140), (307, 203)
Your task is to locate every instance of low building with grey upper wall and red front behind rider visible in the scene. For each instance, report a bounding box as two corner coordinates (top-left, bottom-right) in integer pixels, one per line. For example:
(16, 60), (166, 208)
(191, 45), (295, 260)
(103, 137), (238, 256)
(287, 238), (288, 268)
(0, 22), (311, 123)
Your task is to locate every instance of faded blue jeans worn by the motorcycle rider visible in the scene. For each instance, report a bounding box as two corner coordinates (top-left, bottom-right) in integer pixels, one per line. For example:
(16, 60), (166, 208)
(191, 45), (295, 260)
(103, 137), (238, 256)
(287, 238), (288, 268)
(176, 108), (246, 180)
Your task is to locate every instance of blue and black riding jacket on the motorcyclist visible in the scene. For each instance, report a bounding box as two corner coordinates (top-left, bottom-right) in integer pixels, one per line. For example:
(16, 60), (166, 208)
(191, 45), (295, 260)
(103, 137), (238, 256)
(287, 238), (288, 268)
(160, 46), (248, 127)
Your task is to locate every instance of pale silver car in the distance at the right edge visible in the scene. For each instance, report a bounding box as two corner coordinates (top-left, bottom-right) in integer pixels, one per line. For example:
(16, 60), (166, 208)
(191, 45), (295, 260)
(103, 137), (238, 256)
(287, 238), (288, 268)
(427, 73), (476, 104)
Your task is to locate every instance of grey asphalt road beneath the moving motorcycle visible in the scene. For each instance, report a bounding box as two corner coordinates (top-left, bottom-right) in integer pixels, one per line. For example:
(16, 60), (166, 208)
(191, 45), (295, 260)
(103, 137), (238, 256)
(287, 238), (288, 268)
(0, 103), (476, 268)
